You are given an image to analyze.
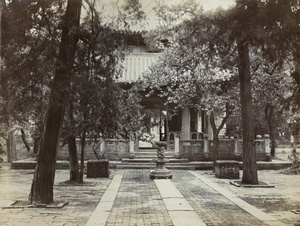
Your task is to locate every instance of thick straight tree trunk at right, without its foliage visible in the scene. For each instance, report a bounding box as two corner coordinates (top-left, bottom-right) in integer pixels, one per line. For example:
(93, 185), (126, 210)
(237, 1), (258, 184)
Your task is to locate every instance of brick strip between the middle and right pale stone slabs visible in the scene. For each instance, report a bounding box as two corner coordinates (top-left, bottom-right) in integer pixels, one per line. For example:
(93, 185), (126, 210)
(173, 171), (264, 225)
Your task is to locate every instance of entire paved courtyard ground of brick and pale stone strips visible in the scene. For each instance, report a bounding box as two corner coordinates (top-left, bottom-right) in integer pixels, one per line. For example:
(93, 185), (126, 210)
(0, 165), (300, 226)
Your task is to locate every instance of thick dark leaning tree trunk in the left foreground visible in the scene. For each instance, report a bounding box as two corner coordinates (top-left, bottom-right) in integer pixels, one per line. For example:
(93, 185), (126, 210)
(29, 0), (82, 204)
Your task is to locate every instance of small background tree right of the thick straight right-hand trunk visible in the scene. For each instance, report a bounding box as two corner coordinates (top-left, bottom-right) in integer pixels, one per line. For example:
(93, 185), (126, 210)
(252, 58), (297, 157)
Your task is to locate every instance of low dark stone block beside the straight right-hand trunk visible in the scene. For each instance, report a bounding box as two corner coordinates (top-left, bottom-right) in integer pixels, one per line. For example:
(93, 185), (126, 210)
(215, 160), (240, 179)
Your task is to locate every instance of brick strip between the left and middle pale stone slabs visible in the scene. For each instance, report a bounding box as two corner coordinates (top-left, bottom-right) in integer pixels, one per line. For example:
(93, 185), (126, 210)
(106, 170), (173, 226)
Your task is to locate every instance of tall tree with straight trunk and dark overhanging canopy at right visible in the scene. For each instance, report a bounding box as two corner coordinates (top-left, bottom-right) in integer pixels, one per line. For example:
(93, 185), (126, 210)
(145, 0), (299, 184)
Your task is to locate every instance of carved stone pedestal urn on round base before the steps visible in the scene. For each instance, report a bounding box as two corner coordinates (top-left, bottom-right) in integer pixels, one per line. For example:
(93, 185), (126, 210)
(150, 141), (173, 179)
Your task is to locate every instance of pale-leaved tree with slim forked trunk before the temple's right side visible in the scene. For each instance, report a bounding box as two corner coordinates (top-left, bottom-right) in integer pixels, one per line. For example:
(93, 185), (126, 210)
(144, 1), (239, 167)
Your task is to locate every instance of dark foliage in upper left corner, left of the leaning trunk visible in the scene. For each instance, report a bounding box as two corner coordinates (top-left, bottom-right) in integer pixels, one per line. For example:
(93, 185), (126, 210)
(1, 1), (61, 162)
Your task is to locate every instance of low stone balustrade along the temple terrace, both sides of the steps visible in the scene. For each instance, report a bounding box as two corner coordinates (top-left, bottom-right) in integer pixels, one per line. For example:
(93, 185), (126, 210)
(58, 131), (271, 161)
